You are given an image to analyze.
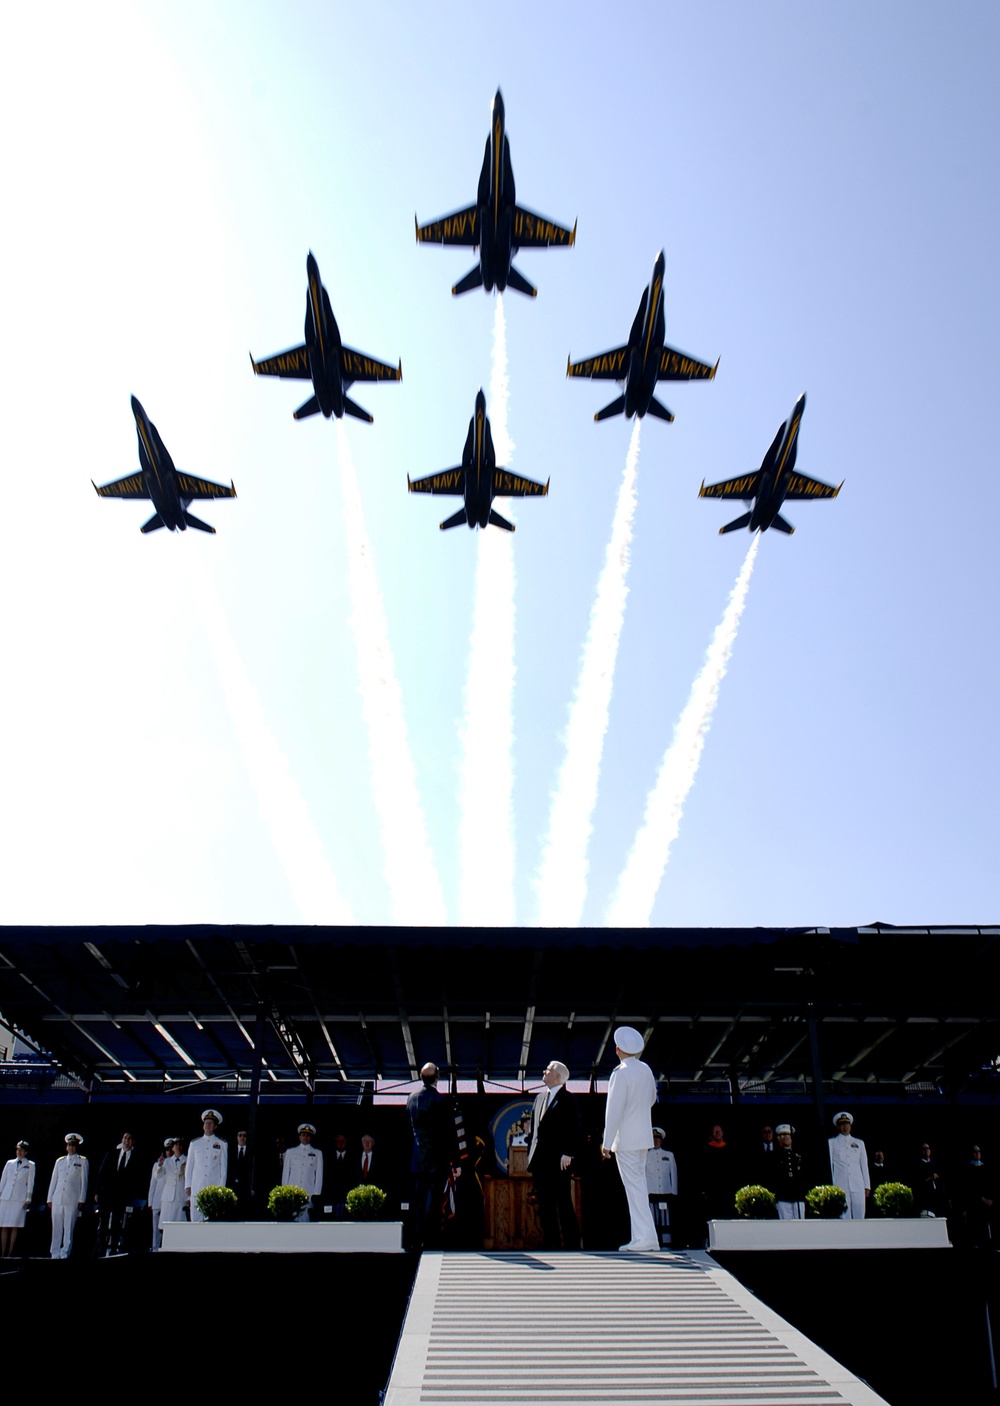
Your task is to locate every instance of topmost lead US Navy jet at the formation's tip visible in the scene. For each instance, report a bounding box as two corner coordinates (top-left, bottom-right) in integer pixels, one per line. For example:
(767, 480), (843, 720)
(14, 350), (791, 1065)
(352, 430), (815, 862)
(414, 89), (577, 298)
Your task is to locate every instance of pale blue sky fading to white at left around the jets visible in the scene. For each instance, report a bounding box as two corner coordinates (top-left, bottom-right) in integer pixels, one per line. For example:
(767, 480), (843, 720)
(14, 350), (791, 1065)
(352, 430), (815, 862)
(0, 0), (1000, 925)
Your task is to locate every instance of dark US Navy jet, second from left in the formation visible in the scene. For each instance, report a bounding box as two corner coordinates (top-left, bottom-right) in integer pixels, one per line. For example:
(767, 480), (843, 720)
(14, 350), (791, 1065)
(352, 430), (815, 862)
(250, 250), (402, 425)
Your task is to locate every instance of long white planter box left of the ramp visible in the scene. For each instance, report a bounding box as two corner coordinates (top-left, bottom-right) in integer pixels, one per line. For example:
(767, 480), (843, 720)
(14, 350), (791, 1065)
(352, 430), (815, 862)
(160, 1220), (402, 1254)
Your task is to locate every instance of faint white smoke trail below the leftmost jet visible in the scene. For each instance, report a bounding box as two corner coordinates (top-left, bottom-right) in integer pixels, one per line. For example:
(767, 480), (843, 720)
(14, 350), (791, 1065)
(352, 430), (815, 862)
(194, 559), (354, 925)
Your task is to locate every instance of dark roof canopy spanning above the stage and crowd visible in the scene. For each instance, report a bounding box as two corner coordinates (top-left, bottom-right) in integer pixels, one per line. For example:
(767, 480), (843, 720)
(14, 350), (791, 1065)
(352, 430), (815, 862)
(0, 925), (1000, 1098)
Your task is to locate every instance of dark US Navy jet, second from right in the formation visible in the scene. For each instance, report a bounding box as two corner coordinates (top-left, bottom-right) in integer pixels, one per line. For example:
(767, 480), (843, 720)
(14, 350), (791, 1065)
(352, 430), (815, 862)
(565, 249), (719, 422)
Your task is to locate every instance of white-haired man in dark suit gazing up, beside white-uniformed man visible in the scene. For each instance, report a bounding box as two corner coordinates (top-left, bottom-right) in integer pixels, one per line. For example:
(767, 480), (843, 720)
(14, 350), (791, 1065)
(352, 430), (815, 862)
(527, 1060), (579, 1250)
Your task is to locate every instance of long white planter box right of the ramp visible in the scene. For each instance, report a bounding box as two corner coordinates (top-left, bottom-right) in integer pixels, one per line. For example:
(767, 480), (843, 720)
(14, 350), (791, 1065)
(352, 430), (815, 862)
(709, 1216), (949, 1250)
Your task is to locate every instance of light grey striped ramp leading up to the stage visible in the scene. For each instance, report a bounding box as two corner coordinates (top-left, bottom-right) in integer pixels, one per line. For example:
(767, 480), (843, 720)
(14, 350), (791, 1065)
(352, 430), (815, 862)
(385, 1251), (883, 1406)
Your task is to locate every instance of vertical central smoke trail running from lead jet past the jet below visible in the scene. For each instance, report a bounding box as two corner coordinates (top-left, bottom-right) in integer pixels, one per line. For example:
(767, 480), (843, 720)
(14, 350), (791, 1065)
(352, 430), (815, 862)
(459, 297), (515, 927)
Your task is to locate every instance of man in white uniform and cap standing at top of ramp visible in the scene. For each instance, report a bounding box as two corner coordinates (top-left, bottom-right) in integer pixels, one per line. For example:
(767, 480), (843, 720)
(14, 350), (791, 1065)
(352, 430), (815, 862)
(601, 1025), (660, 1254)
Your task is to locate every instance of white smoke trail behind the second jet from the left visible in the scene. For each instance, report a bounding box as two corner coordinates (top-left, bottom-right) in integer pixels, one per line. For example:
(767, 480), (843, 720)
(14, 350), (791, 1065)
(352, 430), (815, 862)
(336, 420), (446, 927)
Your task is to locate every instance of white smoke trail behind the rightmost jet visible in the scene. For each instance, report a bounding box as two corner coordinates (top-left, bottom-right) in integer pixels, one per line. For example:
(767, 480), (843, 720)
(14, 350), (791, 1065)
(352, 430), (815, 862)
(605, 533), (759, 928)
